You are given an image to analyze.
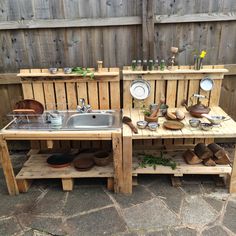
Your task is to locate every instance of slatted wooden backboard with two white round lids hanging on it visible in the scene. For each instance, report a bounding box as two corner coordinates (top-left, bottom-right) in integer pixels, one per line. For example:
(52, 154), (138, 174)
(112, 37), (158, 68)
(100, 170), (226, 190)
(123, 65), (227, 146)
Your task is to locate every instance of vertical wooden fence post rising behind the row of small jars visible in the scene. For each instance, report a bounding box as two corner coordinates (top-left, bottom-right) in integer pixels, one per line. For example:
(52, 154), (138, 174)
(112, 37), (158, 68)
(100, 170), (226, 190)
(142, 0), (154, 60)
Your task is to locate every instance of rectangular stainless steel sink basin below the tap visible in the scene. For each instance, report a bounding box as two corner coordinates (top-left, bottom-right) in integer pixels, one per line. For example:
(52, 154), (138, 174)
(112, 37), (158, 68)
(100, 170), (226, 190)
(66, 112), (115, 130)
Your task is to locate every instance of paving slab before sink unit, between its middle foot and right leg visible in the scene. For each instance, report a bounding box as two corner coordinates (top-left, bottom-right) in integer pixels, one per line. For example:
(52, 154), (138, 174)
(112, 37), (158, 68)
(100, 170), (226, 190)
(63, 186), (113, 216)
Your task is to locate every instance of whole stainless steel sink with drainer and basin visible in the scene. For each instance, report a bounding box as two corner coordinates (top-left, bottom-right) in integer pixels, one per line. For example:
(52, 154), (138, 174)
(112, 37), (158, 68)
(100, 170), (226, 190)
(7, 110), (121, 130)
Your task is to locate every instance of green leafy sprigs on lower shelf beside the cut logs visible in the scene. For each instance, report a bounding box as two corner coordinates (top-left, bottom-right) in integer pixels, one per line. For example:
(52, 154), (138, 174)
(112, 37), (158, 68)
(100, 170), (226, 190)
(139, 152), (177, 170)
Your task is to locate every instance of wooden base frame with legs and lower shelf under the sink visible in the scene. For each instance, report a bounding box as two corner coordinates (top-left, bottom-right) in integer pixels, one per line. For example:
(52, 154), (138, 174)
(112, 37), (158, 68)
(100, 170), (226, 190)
(0, 127), (122, 195)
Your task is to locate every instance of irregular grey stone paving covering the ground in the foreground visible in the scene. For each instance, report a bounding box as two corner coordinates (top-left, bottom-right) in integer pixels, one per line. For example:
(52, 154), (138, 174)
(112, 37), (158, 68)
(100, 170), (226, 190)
(0, 154), (236, 236)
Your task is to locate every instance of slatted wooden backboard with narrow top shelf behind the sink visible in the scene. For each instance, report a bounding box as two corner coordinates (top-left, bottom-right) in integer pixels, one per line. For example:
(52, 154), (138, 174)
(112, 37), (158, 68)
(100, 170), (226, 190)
(18, 68), (121, 149)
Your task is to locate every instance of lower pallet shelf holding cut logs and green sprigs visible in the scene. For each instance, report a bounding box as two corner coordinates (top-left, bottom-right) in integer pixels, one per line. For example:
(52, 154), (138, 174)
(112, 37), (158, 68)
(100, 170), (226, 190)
(133, 151), (232, 176)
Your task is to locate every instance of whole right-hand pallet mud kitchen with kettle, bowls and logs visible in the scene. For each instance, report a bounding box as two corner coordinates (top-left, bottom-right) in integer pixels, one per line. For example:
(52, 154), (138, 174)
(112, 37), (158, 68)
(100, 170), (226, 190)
(123, 65), (236, 193)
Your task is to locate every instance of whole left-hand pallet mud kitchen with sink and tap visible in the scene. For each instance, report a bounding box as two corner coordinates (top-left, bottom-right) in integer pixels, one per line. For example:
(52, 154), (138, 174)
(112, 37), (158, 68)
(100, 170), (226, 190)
(0, 66), (123, 195)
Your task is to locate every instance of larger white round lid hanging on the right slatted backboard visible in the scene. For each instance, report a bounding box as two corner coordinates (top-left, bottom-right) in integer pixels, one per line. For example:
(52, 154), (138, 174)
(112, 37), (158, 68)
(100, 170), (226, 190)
(130, 80), (151, 100)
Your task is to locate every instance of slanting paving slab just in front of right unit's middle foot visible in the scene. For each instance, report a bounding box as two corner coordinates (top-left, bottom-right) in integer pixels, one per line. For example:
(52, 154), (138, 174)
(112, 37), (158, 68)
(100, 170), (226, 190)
(148, 181), (185, 214)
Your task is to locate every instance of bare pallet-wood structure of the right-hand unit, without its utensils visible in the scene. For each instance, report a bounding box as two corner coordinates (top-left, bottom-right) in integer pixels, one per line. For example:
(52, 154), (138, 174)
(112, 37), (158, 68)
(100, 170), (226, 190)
(123, 66), (236, 193)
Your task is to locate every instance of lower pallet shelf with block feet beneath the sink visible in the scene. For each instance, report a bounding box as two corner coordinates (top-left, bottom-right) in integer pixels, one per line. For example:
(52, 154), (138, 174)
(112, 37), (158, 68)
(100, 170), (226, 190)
(16, 154), (114, 192)
